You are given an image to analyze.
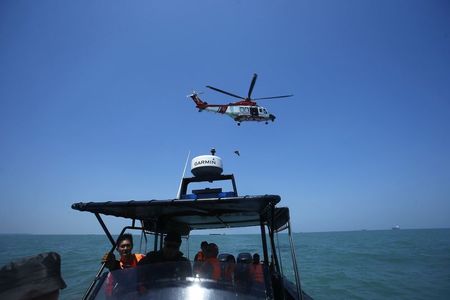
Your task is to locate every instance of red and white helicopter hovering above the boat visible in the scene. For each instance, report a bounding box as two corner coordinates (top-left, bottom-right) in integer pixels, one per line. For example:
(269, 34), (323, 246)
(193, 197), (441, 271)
(188, 74), (293, 126)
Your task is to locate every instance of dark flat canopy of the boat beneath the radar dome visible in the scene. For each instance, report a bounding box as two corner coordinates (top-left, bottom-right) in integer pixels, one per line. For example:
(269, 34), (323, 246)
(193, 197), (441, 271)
(72, 195), (289, 235)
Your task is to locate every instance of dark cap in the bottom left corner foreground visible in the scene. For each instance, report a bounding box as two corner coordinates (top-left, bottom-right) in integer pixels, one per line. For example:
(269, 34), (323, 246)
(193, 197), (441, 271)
(0, 252), (66, 299)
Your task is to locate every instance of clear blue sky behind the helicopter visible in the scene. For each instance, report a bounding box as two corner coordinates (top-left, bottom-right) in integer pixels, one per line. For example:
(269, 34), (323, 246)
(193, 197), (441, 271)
(0, 0), (450, 233)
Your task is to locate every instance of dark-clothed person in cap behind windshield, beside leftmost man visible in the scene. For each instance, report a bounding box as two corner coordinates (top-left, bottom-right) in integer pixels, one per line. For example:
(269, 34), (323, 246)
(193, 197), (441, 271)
(138, 232), (192, 278)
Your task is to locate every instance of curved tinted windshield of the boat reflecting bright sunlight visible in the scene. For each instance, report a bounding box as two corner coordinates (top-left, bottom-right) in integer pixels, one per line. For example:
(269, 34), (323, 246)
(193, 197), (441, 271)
(91, 261), (270, 300)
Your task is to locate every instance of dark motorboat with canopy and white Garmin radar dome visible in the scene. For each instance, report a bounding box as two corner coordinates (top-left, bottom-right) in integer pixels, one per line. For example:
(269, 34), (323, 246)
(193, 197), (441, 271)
(72, 152), (312, 300)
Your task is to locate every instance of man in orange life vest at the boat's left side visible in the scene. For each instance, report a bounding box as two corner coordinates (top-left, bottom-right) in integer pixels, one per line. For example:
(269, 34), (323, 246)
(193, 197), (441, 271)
(102, 233), (145, 271)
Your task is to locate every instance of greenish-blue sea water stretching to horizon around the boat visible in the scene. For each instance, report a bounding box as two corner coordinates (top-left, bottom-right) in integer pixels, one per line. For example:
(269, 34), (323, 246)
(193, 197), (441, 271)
(0, 229), (450, 299)
